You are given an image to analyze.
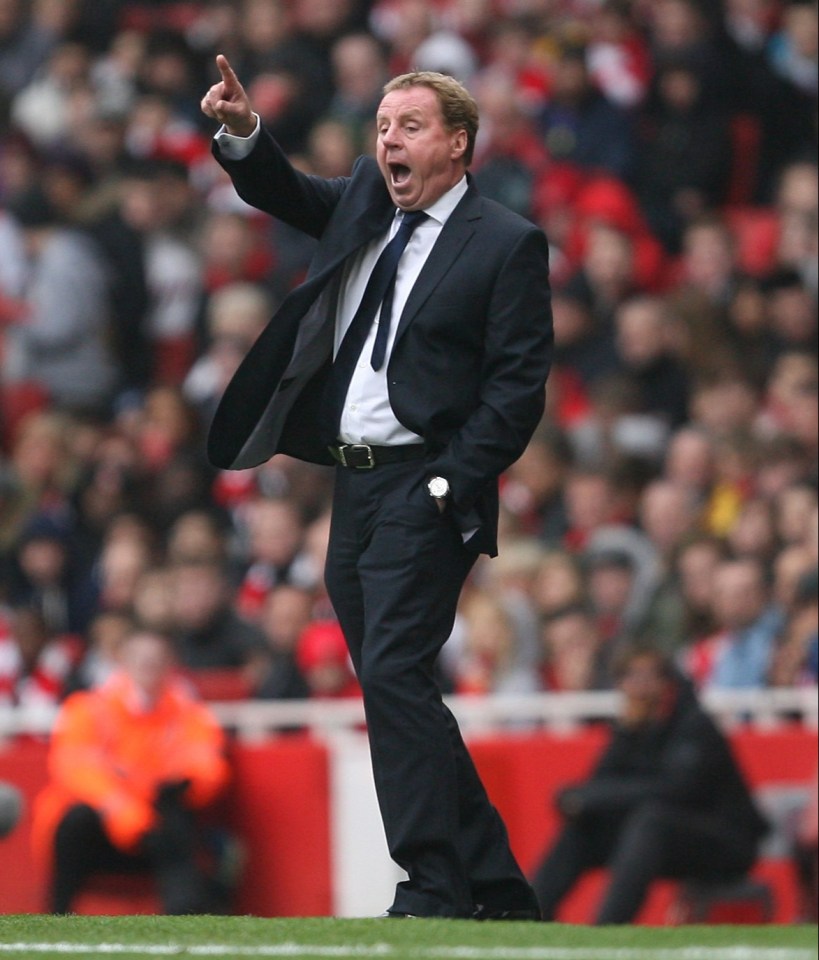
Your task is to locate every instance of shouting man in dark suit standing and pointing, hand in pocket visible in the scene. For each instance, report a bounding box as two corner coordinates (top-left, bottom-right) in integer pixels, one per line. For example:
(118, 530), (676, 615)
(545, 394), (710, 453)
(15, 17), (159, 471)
(202, 56), (552, 919)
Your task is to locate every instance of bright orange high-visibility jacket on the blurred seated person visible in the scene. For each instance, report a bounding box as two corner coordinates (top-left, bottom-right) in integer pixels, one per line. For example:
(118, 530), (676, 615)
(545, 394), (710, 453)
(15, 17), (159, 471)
(32, 674), (230, 859)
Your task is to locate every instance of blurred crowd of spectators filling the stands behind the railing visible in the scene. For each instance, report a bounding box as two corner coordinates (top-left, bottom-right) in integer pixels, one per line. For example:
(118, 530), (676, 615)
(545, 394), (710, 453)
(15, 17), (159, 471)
(0, 0), (819, 705)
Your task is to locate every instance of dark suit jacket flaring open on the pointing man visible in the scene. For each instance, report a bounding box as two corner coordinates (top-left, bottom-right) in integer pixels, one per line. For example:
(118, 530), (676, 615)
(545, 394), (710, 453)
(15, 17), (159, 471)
(208, 124), (553, 553)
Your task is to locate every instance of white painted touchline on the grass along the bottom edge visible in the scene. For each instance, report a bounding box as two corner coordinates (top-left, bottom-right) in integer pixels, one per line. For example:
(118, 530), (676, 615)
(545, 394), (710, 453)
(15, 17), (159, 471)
(0, 942), (816, 960)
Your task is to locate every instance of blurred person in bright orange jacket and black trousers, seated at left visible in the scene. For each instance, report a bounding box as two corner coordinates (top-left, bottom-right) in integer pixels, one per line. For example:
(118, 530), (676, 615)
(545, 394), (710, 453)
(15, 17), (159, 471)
(32, 631), (230, 914)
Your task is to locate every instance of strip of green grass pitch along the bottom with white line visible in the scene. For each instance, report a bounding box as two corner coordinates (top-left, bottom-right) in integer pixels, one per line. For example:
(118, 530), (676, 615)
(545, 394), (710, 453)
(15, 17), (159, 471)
(0, 915), (817, 960)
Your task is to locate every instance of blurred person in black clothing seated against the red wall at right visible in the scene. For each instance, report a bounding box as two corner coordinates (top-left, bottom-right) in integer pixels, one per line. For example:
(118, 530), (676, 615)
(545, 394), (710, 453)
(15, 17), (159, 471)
(533, 650), (767, 924)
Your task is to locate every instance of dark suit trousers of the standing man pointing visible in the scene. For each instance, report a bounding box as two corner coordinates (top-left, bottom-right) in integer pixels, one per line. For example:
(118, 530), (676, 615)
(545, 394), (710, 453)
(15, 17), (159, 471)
(326, 461), (536, 917)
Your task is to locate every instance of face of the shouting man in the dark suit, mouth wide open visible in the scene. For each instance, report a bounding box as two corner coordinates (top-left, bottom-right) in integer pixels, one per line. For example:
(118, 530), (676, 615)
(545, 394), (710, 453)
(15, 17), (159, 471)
(376, 87), (467, 210)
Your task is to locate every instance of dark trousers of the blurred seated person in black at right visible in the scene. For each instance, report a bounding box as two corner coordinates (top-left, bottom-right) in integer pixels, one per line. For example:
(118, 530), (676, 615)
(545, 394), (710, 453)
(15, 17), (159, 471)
(533, 801), (756, 924)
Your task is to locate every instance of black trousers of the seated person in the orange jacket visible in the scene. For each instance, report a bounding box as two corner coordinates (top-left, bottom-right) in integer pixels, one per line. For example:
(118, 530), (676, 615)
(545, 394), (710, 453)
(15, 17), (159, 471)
(50, 804), (207, 915)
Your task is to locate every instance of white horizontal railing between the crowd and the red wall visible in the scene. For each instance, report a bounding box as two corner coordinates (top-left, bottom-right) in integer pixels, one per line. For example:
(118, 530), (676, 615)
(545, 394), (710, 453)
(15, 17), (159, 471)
(0, 687), (819, 740)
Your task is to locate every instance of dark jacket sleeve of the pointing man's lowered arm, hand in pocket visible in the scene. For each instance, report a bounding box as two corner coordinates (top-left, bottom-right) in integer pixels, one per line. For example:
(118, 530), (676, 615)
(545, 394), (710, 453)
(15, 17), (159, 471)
(430, 227), (553, 529)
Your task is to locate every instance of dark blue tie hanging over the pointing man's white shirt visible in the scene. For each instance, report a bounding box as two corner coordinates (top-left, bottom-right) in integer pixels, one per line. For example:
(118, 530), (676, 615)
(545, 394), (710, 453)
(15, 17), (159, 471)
(325, 210), (427, 440)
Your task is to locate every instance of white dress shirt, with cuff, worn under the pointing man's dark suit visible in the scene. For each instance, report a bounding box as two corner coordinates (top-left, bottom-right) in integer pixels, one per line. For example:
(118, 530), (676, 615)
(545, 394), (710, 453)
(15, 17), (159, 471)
(216, 118), (467, 446)
